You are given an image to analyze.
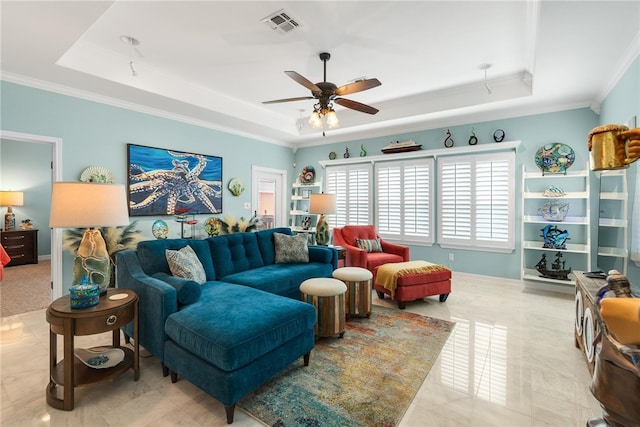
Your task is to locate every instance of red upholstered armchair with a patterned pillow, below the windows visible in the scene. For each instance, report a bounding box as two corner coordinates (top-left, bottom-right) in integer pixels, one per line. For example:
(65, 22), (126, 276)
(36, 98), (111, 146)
(333, 225), (409, 273)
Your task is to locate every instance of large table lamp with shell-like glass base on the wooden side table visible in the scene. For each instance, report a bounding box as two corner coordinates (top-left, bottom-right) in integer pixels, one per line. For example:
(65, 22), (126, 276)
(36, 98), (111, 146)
(49, 182), (129, 295)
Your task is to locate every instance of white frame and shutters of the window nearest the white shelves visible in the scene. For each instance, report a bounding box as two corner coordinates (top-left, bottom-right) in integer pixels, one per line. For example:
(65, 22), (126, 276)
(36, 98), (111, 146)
(438, 151), (516, 253)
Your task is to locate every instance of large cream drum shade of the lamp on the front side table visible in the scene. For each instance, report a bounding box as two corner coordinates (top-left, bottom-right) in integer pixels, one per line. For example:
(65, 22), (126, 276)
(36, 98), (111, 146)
(49, 182), (129, 228)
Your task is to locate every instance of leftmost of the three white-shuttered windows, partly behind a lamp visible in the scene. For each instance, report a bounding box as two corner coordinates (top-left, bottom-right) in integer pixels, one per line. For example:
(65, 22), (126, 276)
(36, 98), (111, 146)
(326, 163), (373, 227)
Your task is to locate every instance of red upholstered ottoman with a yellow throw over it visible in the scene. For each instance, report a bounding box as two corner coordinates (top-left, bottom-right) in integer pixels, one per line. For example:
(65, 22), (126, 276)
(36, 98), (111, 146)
(373, 261), (451, 309)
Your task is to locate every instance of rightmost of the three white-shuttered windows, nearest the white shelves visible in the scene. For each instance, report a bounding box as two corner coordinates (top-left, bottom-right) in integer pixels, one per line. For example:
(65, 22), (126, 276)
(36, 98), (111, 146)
(438, 152), (515, 252)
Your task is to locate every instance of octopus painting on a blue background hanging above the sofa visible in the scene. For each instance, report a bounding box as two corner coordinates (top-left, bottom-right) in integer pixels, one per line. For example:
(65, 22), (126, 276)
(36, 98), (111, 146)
(127, 144), (223, 216)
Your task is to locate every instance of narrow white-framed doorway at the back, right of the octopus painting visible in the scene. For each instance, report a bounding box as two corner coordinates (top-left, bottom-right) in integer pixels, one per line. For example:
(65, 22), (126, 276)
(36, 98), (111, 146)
(251, 166), (287, 229)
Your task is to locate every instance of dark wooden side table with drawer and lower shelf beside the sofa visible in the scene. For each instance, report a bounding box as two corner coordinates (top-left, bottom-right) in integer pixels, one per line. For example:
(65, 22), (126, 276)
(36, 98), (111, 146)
(46, 289), (140, 411)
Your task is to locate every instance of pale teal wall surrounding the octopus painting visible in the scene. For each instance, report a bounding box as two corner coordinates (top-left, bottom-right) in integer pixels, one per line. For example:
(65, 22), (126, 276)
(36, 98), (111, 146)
(0, 81), (293, 292)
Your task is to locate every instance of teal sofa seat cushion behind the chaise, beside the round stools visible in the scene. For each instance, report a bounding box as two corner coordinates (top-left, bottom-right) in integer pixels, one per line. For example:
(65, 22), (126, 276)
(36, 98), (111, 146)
(221, 262), (333, 299)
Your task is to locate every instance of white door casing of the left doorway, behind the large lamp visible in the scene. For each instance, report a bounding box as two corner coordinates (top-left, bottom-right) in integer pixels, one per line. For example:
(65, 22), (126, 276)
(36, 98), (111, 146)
(0, 130), (62, 301)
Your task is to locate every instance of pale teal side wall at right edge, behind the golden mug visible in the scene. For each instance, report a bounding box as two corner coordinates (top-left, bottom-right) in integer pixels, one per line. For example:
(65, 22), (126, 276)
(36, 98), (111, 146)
(600, 57), (640, 293)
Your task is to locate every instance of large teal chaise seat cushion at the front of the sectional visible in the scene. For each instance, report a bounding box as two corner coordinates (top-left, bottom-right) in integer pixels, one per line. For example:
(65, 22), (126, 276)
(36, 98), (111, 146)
(165, 282), (316, 372)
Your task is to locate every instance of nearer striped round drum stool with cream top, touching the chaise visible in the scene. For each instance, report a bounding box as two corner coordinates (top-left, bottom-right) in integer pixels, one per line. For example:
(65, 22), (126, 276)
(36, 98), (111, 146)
(300, 277), (347, 338)
